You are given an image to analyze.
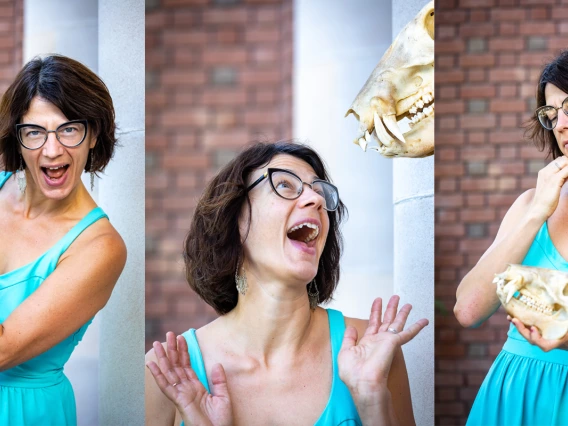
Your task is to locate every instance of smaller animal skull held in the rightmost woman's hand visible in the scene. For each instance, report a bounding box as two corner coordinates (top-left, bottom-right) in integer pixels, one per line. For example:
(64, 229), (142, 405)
(493, 265), (568, 339)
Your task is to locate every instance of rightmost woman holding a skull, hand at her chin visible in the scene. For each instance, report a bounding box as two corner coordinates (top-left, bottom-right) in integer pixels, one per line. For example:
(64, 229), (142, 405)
(454, 51), (568, 425)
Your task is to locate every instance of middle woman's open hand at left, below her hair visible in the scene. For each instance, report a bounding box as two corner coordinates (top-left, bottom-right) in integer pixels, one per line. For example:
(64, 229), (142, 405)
(147, 332), (233, 426)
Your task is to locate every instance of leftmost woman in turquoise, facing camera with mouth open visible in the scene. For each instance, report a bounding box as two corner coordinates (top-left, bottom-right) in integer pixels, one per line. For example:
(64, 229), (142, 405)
(0, 56), (126, 426)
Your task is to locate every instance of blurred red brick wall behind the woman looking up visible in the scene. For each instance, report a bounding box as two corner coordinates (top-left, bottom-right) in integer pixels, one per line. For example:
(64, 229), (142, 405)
(146, 0), (293, 348)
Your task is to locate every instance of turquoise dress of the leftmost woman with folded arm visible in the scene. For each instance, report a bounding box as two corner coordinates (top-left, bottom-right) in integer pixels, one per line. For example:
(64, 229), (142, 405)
(0, 172), (107, 426)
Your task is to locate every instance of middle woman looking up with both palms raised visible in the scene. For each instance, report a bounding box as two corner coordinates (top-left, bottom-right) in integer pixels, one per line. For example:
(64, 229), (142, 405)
(146, 143), (427, 425)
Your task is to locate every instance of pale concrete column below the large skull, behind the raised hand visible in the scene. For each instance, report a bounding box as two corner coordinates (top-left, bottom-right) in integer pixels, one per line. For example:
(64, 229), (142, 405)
(392, 0), (434, 425)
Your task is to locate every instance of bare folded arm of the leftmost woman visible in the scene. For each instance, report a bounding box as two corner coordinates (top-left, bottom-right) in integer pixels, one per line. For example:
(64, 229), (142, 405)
(0, 222), (126, 370)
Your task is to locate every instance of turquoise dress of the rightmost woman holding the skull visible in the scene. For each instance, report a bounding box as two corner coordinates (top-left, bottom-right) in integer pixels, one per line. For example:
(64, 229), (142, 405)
(467, 222), (568, 426)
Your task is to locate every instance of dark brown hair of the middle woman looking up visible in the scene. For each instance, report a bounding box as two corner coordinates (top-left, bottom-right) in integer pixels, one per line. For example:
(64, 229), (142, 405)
(183, 142), (347, 314)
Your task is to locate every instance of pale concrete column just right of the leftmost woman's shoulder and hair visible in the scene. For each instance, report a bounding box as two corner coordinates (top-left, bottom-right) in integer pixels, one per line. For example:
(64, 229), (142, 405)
(98, 0), (145, 425)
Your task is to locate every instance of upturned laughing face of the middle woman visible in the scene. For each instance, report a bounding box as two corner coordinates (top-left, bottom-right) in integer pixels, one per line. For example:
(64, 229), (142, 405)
(239, 154), (329, 284)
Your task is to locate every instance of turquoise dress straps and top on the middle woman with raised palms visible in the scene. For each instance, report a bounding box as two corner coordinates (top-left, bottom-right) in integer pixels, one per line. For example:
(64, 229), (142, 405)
(182, 309), (362, 426)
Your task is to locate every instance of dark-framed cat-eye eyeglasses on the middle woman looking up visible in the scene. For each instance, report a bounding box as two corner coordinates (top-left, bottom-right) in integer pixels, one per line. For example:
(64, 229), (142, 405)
(247, 168), (339, 211)
